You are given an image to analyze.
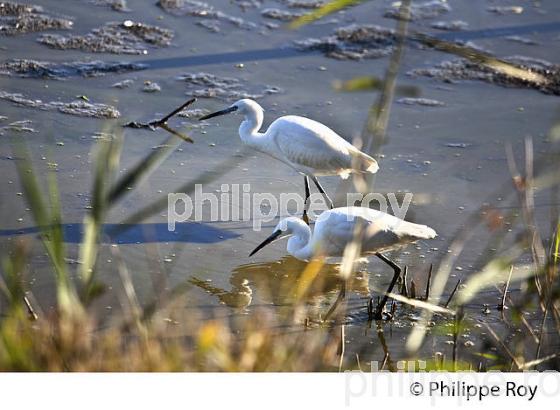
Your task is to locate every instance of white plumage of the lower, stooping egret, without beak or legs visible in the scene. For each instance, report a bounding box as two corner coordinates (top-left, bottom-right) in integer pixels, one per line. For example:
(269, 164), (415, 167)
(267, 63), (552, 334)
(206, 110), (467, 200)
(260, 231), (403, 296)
(262, 207), (437, 260)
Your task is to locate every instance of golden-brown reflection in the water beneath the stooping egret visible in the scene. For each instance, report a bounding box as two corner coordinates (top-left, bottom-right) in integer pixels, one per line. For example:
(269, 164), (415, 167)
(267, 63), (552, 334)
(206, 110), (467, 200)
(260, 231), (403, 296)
(189, 256), (370, 316)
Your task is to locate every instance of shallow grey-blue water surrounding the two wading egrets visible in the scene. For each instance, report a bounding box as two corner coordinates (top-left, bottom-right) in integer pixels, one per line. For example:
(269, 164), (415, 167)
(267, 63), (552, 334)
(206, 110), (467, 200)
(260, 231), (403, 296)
(0, 0), (560, 366)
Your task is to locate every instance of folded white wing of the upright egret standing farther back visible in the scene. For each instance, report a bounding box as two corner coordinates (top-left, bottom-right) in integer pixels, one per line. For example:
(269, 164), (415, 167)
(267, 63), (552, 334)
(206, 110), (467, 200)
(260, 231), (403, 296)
(270, 116), (354, 170)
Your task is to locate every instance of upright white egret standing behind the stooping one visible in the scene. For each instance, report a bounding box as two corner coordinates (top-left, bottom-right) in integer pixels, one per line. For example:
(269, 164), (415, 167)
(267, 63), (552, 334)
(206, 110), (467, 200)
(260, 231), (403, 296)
(200, 98), (379, 222)
